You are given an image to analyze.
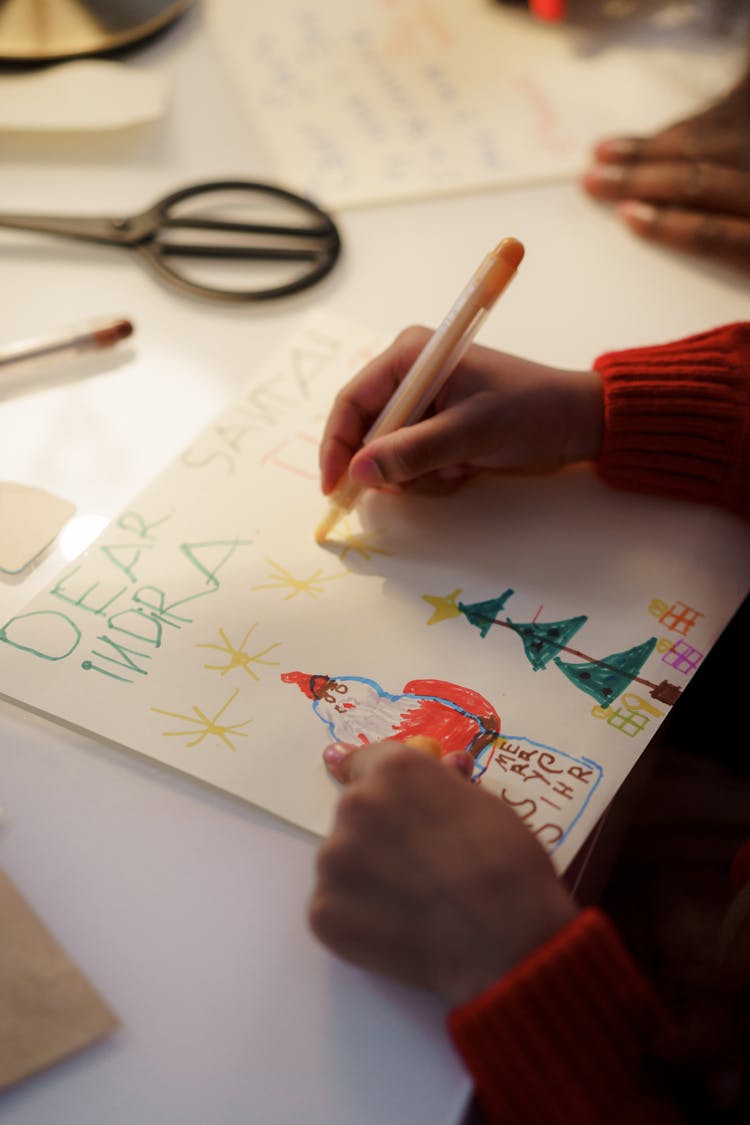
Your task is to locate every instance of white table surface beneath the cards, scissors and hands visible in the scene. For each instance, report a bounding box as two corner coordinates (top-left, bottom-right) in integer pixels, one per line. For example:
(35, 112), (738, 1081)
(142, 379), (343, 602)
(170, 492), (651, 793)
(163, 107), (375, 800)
(0, 8), (750, 1125)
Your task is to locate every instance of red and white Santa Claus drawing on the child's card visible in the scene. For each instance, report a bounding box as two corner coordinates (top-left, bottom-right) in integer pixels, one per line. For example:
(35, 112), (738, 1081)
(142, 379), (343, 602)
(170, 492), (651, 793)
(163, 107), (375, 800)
(281, 672), (500, 758)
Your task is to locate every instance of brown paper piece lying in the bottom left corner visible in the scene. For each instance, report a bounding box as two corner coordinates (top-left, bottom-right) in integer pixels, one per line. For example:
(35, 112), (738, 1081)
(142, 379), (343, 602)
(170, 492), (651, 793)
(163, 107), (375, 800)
(0, 871), (117, 1090)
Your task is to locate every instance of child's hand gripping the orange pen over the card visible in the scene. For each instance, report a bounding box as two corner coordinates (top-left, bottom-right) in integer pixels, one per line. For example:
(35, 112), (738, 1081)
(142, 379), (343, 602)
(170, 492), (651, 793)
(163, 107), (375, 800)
(320, 327), (603, 494)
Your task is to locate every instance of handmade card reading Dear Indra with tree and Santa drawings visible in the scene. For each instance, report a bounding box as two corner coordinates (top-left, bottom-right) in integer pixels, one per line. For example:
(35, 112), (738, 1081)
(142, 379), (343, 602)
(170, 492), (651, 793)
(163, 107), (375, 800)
(0, 313), (750, 869)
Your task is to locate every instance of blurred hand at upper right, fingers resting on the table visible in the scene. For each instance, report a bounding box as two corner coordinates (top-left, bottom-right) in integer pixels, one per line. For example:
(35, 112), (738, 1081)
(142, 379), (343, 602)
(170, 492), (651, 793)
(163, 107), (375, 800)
(582, 70), (750, 273)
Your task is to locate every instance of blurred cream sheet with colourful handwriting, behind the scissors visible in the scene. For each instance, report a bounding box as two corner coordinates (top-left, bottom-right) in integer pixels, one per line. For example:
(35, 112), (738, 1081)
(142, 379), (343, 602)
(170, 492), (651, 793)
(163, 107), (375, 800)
(207, 0), (743, 207)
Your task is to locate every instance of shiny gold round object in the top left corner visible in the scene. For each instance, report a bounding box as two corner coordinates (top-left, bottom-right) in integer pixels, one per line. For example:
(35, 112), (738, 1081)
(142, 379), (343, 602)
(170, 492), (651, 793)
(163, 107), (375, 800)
(0, 0), (192, 62)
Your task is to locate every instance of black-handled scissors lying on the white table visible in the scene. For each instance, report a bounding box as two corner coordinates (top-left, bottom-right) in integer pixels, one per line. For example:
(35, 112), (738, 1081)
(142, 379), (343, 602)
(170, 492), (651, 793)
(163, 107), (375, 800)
(0, 180), (341, 302)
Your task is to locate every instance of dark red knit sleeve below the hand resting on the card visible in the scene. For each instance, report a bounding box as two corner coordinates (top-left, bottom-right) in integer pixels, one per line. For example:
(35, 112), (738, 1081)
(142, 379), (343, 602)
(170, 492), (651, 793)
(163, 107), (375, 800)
(448, 908), (684, 1125)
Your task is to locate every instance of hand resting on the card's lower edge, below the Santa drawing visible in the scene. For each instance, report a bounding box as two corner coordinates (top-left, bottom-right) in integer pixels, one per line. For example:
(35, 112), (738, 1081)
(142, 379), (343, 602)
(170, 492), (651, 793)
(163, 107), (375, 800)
(309, 743), (578, 1007)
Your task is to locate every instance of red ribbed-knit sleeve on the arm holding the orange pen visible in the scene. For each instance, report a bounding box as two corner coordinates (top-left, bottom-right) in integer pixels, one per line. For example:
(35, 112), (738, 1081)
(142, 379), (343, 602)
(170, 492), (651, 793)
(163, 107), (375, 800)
(594, 323), (750, 516)
